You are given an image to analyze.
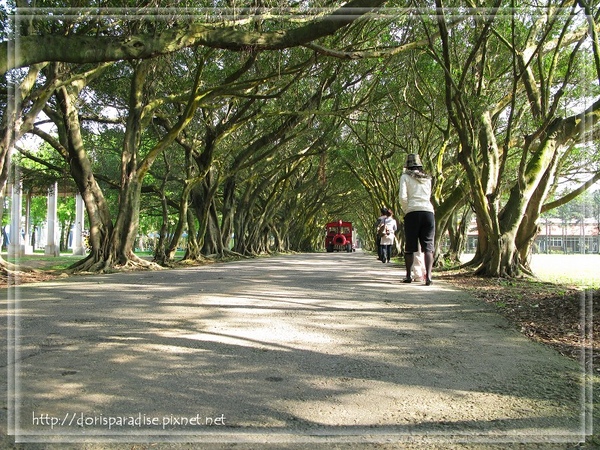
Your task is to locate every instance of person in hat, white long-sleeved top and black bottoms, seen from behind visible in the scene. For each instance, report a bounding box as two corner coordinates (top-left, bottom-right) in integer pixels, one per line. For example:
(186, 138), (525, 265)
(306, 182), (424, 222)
(400, 154), (435, 286)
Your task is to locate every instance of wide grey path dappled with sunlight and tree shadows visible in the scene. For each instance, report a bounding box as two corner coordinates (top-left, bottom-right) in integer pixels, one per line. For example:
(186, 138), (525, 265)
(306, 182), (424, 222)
(0, 252), (591, 449)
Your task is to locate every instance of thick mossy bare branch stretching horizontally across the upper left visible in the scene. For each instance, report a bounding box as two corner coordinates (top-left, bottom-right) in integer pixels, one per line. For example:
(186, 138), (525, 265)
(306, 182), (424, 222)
(0, 0), (385, 74)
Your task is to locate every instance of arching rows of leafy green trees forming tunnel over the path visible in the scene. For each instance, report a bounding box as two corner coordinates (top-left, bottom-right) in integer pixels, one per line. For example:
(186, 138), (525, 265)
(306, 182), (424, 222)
(0, 0), (600, 276)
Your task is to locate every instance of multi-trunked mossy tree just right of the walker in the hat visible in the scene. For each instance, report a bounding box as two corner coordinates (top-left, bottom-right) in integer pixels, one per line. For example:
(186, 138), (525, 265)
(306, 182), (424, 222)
(432, 0), (600, 276)
